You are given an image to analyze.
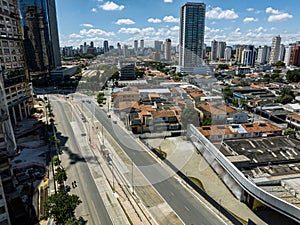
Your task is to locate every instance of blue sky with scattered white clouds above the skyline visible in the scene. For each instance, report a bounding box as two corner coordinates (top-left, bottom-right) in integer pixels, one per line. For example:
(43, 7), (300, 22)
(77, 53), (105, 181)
(56, 0), (300, 47)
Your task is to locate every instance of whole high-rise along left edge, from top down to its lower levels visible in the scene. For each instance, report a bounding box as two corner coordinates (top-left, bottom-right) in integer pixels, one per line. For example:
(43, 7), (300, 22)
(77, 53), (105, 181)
(0, 0), (32, 224)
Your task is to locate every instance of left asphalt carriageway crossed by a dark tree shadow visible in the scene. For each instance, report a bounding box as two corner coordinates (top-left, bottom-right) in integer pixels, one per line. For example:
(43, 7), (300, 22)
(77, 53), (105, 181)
(51, 97), (113, 225)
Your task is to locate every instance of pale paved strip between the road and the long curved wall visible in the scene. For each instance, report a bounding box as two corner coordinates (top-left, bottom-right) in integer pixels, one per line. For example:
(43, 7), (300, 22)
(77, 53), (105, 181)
(146, 137), (266, 225)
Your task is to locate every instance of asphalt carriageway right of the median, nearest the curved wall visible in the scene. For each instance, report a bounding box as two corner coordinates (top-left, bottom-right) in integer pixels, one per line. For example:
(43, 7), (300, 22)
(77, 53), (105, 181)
(84, 99), (224, 225)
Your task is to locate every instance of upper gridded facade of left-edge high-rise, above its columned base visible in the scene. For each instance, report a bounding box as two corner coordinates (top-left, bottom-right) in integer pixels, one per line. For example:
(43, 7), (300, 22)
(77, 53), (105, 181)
(0, 0), (32, 125)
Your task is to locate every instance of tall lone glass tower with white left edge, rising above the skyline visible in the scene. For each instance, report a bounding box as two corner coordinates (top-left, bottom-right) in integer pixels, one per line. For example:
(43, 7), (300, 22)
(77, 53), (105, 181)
(179, 2), (206, 73)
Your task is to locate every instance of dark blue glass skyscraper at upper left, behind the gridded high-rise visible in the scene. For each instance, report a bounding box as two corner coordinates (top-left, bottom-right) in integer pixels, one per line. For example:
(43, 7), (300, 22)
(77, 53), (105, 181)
(19, 0), (61, 80)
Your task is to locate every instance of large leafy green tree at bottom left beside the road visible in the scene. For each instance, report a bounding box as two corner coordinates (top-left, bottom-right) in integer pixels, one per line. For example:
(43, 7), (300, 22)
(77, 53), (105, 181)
(45, 191), (82, 224)
